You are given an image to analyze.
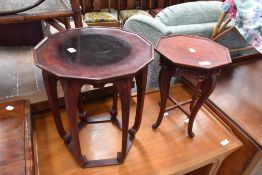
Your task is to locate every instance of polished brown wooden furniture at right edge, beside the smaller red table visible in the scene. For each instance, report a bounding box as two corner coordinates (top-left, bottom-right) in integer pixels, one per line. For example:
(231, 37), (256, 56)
(183, 56), (262, 175)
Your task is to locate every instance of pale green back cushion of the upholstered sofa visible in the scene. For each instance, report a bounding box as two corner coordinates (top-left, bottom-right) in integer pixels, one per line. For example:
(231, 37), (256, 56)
(155, 1), (222, 26)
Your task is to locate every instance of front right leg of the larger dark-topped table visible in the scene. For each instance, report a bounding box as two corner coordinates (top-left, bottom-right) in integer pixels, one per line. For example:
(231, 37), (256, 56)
(114, 79), (132, 162)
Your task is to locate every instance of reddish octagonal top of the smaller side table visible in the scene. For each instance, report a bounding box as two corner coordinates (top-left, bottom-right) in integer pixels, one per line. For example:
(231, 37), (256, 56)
(156, 35), (231, 70)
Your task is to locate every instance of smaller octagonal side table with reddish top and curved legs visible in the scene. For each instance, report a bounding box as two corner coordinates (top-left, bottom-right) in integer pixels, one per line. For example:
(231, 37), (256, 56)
(152, 35), (231, 138)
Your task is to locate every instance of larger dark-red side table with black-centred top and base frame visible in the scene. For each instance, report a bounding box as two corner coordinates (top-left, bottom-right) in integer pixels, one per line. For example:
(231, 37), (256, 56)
(34, 28), (153, 167)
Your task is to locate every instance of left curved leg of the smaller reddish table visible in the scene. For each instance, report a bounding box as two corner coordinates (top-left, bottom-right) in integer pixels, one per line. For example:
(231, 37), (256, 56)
(152, 66), (173, 129)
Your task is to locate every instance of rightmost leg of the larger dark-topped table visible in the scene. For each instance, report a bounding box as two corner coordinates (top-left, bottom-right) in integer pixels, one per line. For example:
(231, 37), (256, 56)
(129, 66), (148, 138)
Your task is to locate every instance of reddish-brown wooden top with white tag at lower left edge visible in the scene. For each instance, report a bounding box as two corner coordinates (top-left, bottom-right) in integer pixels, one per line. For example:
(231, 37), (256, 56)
(0, 100), (38, 175)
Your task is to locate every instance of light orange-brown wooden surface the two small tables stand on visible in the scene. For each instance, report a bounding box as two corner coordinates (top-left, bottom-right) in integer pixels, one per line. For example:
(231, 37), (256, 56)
(33, 85), (241, 175)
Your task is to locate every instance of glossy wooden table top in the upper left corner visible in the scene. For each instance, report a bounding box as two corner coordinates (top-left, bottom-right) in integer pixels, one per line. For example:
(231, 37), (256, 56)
(0, 0), (73, 23)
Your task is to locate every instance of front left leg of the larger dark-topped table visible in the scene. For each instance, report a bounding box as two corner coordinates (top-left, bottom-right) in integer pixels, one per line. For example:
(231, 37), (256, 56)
(60, 79), (86, 167)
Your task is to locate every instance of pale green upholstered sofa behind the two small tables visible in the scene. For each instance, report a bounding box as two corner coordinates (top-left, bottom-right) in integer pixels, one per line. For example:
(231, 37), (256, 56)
(124, 1), (255, 88)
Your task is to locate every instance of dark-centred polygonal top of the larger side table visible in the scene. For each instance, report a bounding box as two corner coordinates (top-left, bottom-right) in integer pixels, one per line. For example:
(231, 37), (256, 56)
(33, 27), (153, 80)
